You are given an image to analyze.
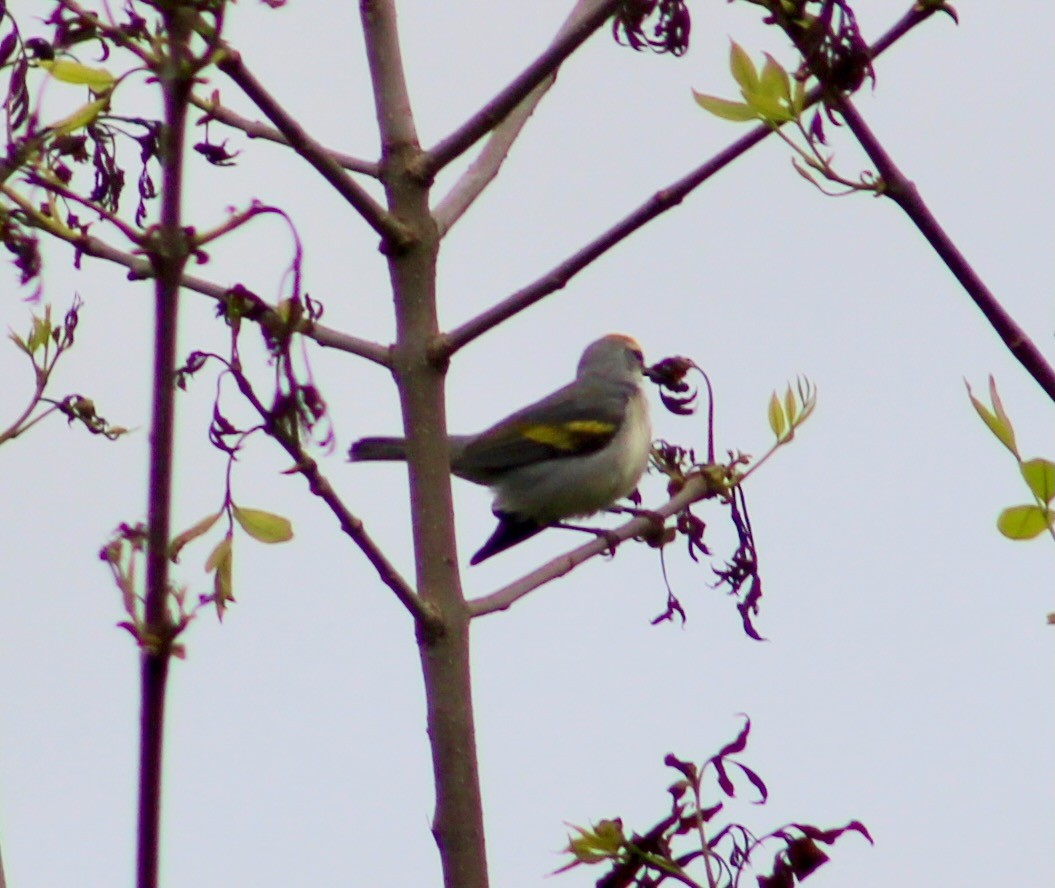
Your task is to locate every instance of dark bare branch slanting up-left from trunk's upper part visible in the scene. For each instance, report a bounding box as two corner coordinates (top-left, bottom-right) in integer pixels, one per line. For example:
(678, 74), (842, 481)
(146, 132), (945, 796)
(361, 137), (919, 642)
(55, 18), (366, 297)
(216, 46), (414, 251)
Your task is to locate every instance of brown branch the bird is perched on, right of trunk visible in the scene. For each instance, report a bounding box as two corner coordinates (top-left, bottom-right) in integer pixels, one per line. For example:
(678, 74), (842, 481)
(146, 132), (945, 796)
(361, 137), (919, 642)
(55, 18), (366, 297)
(468, 472), (714, 617)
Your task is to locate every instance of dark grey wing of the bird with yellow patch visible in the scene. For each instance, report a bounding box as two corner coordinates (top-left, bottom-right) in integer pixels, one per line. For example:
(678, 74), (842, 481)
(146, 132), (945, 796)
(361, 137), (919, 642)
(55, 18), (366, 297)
(454, 381), (632, 478)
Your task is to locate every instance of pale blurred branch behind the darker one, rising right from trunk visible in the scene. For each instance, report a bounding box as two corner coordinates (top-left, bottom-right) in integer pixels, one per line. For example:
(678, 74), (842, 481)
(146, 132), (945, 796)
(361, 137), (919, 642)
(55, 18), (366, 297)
(433, 0), (605, 237)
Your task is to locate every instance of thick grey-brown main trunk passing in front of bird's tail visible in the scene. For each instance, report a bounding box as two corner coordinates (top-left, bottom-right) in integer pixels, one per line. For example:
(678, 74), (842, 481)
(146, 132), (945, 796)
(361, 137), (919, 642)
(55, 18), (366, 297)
(360, 0), (487, 888)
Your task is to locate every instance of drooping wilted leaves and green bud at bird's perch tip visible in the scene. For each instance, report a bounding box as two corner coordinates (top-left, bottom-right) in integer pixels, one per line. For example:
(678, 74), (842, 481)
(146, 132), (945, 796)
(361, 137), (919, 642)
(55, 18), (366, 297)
(651, 375), (817, 641)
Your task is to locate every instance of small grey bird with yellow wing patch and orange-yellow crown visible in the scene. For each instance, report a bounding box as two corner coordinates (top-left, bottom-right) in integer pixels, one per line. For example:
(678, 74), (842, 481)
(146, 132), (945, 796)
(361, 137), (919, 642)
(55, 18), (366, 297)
(348, 333), (652, 564)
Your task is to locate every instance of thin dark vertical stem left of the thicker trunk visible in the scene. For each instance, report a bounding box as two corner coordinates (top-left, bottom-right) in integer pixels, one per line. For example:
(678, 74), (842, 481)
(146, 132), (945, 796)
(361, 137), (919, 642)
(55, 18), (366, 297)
(136, 6), (193, 888)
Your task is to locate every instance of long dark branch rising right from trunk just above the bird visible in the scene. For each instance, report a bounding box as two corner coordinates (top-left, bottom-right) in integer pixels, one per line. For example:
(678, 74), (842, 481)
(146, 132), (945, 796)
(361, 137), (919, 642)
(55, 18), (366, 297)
(435, 7), (933, 359)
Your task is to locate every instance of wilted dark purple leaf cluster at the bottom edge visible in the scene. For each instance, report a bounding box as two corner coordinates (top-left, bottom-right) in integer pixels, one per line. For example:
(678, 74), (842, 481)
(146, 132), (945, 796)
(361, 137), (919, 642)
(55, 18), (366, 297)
(557, 719), (871, 888)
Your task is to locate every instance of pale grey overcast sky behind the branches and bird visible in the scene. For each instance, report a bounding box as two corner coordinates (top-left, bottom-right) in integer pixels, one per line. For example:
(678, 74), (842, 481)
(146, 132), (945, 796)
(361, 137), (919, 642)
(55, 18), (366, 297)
(0, 0), (1055, 888)
